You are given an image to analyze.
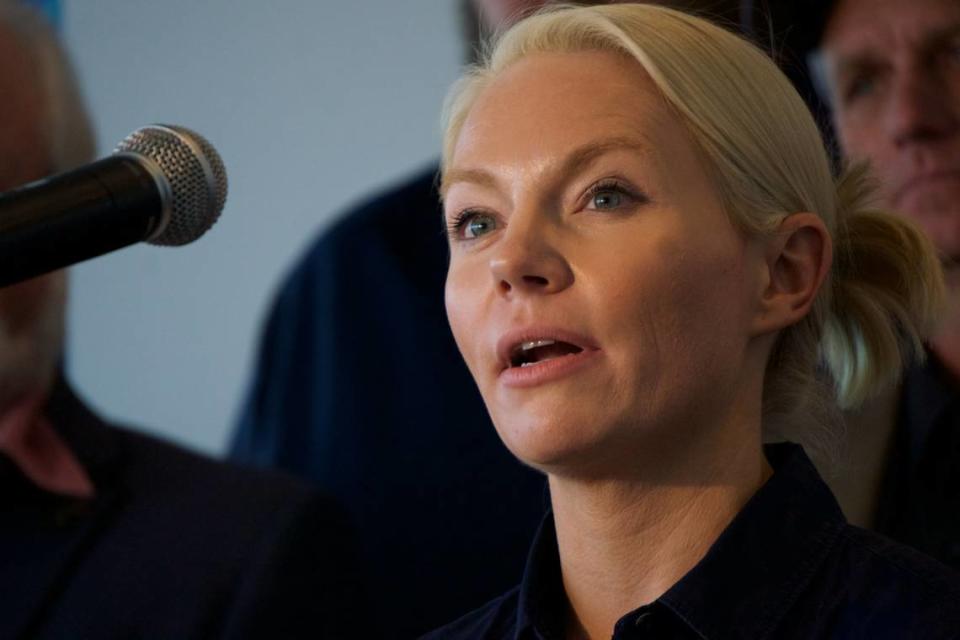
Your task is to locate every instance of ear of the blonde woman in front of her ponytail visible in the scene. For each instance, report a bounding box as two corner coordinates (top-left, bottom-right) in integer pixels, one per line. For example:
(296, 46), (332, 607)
(753, 212), (833, 335)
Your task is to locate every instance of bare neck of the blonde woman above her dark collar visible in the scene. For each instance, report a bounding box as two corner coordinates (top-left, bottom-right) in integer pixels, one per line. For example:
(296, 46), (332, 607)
(550, 420), (772, 639)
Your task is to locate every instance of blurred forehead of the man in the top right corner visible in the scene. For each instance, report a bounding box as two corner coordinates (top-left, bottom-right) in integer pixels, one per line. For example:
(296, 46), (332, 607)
(823, 0), (960, 58)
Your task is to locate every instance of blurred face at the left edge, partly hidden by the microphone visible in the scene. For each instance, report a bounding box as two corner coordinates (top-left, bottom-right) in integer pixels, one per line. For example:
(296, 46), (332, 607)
(0, 29), (66, 411)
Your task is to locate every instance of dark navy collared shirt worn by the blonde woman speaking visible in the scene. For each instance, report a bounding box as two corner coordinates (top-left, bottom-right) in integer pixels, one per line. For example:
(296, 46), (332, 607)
(425, 444), (960, 640)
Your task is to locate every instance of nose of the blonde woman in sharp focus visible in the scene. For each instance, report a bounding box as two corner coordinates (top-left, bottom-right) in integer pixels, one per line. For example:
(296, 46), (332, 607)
(490, 217), (574, 298)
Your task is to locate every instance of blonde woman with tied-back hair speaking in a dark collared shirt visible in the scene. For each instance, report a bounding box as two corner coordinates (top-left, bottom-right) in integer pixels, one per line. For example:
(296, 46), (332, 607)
(430, 5), (960, 638)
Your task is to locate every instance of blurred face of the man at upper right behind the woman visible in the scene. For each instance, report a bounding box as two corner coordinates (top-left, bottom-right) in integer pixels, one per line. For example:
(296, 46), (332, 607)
(821, 0), (960, 260)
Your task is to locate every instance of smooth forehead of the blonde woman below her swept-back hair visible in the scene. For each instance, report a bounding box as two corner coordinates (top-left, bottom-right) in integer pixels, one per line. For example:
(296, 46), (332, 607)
(451, 52), (683, 166)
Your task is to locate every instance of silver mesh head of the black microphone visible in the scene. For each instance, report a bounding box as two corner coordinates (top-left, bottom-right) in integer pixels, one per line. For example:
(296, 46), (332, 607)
(116, 125), (227, 246)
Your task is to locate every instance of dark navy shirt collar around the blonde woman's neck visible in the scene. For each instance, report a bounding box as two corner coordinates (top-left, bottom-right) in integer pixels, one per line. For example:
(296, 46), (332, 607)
(516, 443), (845, 640)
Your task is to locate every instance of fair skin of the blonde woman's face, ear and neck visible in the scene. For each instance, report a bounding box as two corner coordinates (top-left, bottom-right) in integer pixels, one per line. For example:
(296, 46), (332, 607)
(443, 52), (830, 638)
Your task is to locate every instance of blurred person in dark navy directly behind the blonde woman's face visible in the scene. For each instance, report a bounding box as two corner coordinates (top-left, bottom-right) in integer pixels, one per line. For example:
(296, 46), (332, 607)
(232, 0), (735, 638)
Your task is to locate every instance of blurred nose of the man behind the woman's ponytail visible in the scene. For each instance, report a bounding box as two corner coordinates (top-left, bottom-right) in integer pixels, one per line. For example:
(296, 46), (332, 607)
(886, 65), (960, 147)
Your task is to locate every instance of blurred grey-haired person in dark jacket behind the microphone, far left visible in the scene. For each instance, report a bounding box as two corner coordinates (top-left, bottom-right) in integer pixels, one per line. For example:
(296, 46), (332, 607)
(0, 2), (368, 638)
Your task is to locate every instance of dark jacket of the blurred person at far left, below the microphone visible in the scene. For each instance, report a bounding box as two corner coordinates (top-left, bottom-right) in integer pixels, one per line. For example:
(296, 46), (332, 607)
(0, 383), (376, 640)
